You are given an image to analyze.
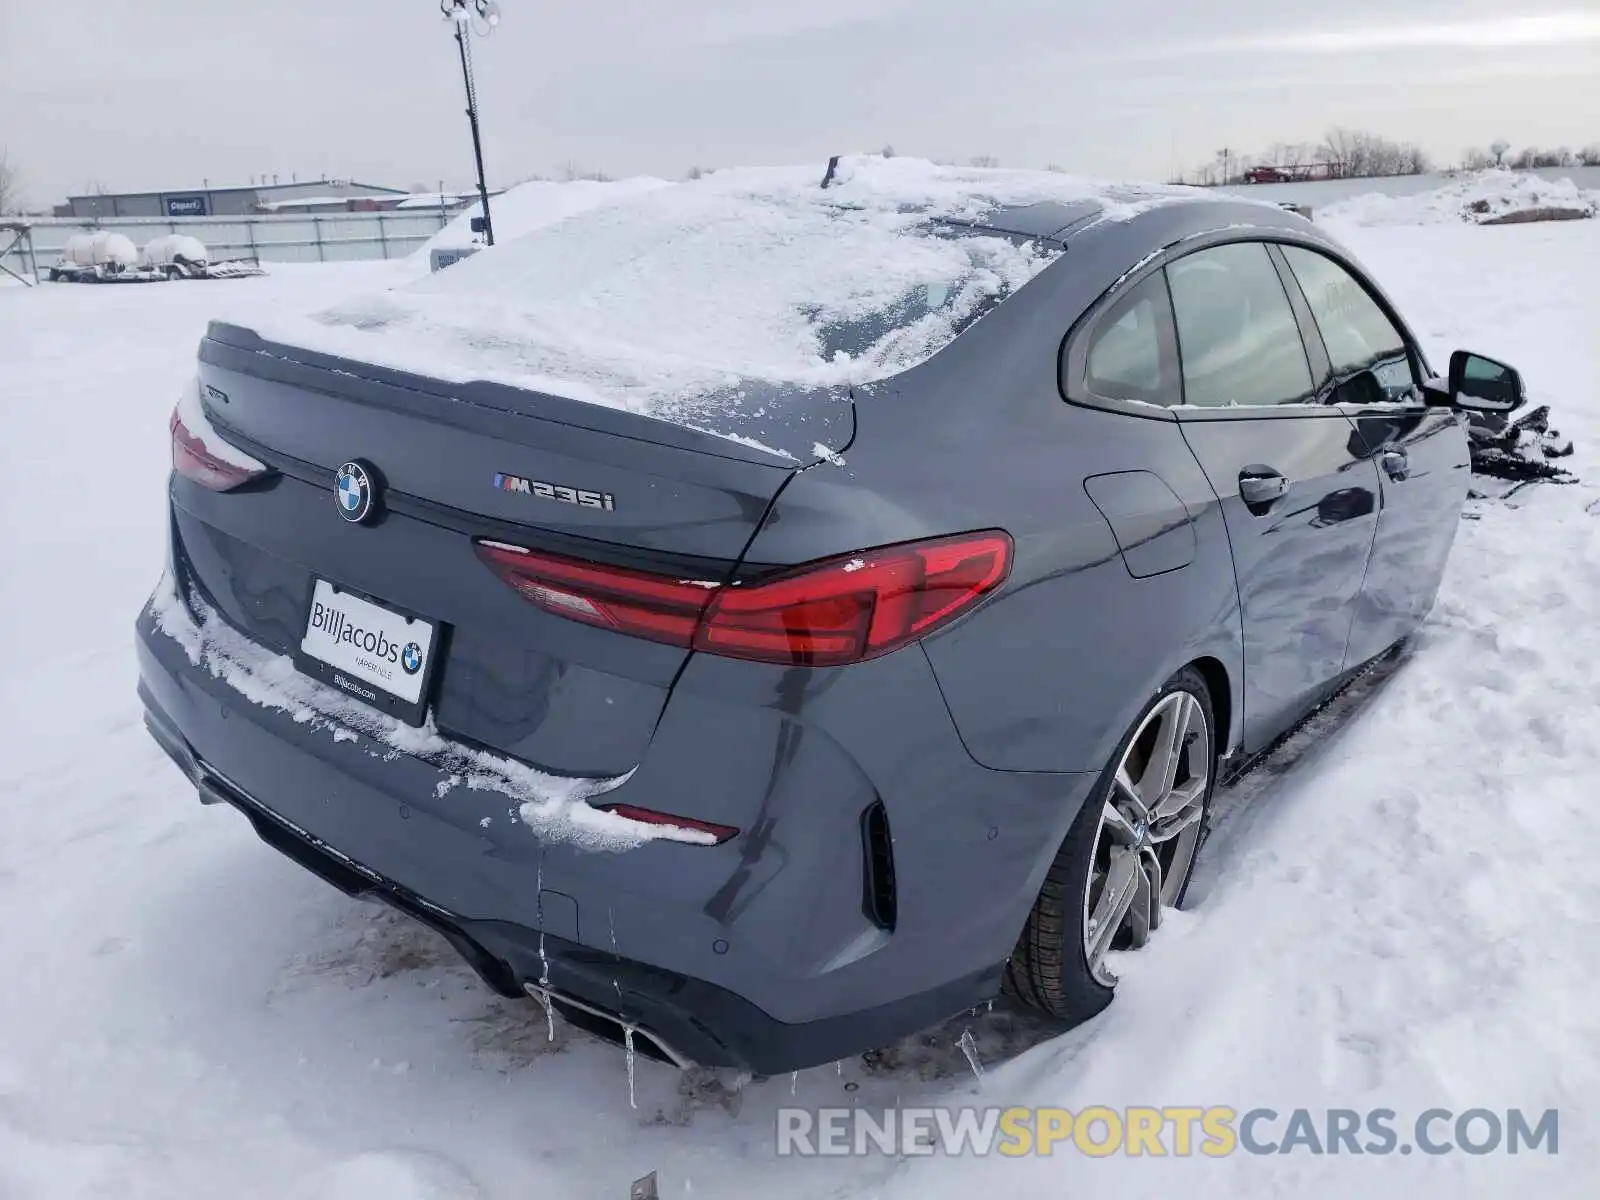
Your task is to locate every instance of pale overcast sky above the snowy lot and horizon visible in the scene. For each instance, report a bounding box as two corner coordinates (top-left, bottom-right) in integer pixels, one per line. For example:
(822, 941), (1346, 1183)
(0, 0), (1600, 203)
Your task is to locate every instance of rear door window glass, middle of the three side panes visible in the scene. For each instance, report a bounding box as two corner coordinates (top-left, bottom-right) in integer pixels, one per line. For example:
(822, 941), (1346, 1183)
(1166, 242), (1312, 408)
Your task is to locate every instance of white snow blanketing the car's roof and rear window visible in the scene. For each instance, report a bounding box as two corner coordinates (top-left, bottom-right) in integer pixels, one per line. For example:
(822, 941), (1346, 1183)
(258, 157), (1202, 432)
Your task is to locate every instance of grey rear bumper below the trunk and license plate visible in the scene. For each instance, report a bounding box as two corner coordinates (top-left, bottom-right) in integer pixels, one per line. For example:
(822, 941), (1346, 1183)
(138, 579), (1093, 1074)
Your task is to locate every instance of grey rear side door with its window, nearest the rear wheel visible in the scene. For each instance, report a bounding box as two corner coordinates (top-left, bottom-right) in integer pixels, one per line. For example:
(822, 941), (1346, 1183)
(1166, 242), (1379, 750)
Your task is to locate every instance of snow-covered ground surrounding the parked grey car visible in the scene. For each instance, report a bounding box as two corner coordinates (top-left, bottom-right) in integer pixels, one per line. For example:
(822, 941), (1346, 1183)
(0, 211), (1600, 1200)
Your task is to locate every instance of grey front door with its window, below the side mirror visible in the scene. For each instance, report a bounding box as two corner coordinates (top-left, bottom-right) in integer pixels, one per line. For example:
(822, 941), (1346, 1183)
(1277, 245), (1470, 667)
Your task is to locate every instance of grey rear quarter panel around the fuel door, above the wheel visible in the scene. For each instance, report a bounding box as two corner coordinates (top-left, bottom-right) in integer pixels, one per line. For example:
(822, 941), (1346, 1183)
(746, 208), (1242, 771)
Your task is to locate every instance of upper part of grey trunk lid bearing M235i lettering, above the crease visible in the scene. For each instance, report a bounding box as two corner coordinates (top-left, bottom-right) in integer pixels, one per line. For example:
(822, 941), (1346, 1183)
(200, 323), (854, 560)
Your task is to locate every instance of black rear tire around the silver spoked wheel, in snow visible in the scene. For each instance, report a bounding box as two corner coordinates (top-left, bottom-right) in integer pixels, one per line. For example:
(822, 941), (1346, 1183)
(1002, 667), (1216, 1027)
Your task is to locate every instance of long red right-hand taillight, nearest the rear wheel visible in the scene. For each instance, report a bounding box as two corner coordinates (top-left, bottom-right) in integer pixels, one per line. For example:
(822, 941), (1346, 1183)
(478, 530), (1011, 667)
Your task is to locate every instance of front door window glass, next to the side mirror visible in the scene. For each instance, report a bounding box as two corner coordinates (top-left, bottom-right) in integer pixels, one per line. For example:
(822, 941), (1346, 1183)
(1282, 246), (1418, 403)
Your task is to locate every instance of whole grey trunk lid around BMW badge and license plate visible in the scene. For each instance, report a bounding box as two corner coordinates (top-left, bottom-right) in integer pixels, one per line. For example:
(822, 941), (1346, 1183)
(174, 325), (854, 776)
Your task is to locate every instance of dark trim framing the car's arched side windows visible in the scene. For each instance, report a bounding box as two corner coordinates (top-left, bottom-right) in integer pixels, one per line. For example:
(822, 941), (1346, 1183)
(1056, 226), (1435, 422)
